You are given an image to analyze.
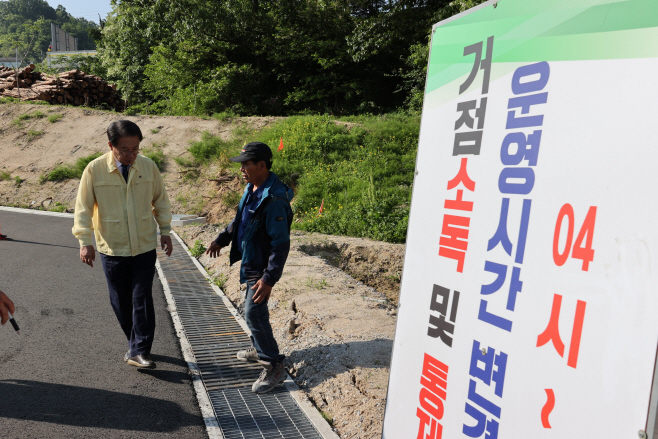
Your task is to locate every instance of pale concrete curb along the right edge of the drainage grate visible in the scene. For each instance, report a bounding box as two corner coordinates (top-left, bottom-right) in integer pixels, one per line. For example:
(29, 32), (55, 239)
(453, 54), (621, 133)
(171, 230), (340, 439)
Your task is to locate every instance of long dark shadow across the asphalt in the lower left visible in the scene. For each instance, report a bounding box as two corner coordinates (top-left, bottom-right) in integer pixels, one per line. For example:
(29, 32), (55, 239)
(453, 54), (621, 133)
(0, 380), (199, 432)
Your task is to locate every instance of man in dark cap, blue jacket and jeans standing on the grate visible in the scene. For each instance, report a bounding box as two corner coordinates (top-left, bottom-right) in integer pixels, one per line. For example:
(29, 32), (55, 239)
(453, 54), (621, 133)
(206, 142), (293, 393)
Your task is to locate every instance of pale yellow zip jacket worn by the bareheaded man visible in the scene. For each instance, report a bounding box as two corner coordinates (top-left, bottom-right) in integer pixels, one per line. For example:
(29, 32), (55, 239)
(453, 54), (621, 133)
(73, 152), (171, 256)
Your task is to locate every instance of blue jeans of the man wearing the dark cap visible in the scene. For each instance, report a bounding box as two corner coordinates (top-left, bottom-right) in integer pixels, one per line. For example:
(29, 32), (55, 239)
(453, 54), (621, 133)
(244, 281), (285, 363)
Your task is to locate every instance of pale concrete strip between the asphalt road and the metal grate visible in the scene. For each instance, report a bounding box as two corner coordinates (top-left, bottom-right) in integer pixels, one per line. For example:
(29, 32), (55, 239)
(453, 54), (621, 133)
(155, 260), (224, 439)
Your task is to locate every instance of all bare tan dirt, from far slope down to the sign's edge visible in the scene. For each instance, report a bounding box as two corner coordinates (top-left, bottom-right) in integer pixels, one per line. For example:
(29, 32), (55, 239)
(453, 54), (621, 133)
(0, 104), (404, 439)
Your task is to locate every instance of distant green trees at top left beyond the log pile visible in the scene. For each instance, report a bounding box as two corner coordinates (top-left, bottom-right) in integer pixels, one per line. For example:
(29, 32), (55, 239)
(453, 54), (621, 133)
(0, 0), (98, 62)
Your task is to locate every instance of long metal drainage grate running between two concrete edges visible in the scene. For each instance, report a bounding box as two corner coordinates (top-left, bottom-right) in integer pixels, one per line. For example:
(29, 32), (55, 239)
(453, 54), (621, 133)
(158, 239), (322, 439)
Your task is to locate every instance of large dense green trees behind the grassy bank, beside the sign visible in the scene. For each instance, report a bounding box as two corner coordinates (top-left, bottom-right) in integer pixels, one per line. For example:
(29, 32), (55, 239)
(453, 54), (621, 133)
(98, 0), (481, 115)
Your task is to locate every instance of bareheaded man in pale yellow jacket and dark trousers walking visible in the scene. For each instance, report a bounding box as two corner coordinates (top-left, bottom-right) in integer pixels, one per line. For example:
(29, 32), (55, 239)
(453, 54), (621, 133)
(73, 120), (172, 368)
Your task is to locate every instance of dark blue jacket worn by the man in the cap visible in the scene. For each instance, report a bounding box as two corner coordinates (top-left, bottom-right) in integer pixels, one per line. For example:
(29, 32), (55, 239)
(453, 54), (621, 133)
(215, 172), (294, 286)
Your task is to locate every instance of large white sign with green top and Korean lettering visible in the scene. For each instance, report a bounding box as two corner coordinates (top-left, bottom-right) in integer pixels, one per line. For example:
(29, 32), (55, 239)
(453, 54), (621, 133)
(383, 0), (658, 439)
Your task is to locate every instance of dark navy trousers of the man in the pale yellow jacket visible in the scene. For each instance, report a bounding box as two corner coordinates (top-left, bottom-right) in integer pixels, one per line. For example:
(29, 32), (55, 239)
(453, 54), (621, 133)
(101, 250), (157, 357)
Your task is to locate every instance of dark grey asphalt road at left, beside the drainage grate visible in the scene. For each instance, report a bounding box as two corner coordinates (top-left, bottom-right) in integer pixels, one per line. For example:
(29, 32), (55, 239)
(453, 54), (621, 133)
(0, 210), (207, 439)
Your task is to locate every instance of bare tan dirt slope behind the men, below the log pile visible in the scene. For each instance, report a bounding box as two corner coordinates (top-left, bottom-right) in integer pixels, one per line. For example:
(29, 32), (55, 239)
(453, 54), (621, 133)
(0, 104), (276, 221)
